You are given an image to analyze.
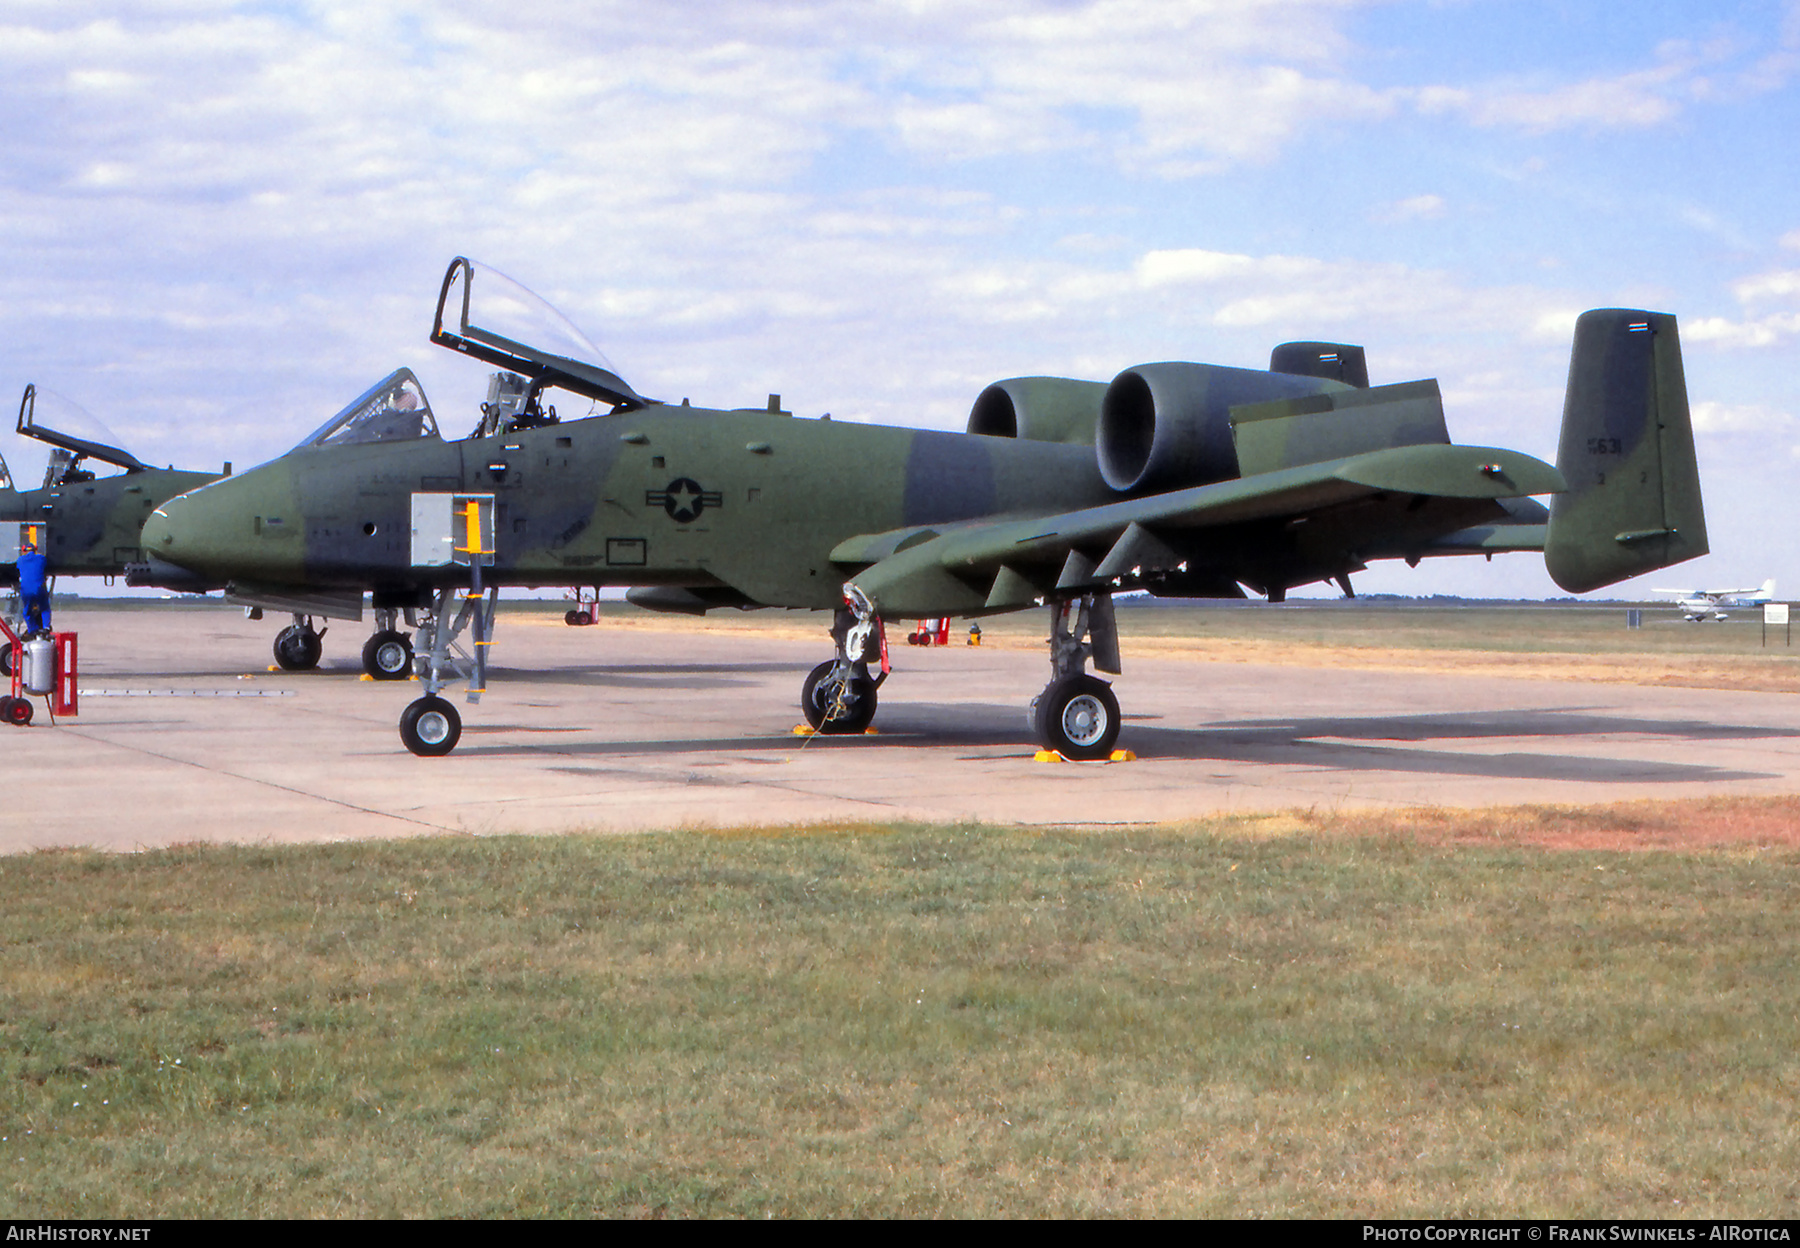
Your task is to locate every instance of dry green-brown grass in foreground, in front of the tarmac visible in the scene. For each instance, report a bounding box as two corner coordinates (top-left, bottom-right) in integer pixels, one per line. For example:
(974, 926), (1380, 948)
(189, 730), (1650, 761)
(0, 800), (1800, 1217)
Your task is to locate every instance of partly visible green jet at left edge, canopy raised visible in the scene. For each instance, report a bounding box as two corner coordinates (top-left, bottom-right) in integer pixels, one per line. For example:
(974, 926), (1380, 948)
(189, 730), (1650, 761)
(0, 385), (229, 674)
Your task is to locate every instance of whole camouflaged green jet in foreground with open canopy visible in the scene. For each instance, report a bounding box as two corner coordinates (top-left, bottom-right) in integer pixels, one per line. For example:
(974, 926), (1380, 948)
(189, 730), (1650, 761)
(144, 258), (1706, 758)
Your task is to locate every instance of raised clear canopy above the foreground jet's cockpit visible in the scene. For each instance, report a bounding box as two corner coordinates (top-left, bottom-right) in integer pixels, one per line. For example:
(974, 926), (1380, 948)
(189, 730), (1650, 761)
(432, 256), (652, 411)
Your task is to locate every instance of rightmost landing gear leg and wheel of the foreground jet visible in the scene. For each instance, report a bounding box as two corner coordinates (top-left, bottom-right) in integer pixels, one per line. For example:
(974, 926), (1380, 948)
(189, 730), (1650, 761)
(1028, 594), (1120, 760)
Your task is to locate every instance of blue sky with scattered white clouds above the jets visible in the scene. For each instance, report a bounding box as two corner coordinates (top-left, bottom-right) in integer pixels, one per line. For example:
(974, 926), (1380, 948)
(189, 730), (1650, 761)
(0, 0), (1800, 596)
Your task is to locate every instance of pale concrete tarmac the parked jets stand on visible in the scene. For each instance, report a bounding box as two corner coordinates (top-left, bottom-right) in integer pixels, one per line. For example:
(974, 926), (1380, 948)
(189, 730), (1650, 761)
(0, 607), (1800, 852)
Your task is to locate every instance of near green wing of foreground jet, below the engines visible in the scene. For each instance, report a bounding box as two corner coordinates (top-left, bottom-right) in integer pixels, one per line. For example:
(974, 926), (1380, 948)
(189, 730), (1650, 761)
(832, 445), (1566, 616)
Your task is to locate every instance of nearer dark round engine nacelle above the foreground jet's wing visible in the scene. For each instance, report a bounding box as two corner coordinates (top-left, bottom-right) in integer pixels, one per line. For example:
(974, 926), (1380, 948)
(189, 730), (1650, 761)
(1094, 364), (1350, 492)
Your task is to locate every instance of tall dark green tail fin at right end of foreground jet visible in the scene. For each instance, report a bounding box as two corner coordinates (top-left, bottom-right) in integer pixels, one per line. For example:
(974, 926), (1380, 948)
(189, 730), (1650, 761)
(1544, 308), (1706, 594)
